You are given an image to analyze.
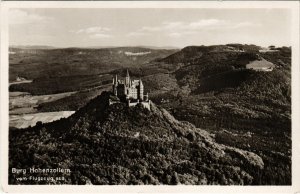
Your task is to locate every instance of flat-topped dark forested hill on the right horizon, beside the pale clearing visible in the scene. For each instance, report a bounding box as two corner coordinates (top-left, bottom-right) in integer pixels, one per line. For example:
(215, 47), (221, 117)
(159, 44), (291, 92)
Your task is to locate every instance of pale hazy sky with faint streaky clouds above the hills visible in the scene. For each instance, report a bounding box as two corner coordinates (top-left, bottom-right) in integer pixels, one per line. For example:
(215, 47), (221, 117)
(9, 8), (291, 47)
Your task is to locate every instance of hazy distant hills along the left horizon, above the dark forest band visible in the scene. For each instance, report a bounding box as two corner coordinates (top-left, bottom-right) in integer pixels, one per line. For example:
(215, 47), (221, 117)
(9, 47), (177, 80)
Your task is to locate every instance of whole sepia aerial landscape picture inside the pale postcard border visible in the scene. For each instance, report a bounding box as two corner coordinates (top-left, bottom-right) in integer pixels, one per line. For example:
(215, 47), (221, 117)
(1, 2), (299, 192)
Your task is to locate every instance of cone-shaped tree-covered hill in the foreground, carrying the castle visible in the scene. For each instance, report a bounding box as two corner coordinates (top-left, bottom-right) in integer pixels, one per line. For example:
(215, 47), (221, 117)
(9, 92), (264, 185)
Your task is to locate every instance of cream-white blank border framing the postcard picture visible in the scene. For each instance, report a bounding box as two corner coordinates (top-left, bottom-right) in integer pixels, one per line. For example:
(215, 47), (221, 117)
(0, 1), (300, 193)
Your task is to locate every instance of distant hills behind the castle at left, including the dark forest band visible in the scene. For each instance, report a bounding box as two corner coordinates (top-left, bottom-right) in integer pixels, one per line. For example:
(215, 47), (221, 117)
(9, 47), (177, 95)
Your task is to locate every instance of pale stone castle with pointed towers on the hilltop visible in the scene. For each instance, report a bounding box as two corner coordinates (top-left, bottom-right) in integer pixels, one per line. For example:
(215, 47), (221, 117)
(109, 70), (150, 110)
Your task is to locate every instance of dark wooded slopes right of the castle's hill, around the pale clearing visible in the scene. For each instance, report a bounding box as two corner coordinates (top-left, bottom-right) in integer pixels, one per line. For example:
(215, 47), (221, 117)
(150, 45), (291, 185)
